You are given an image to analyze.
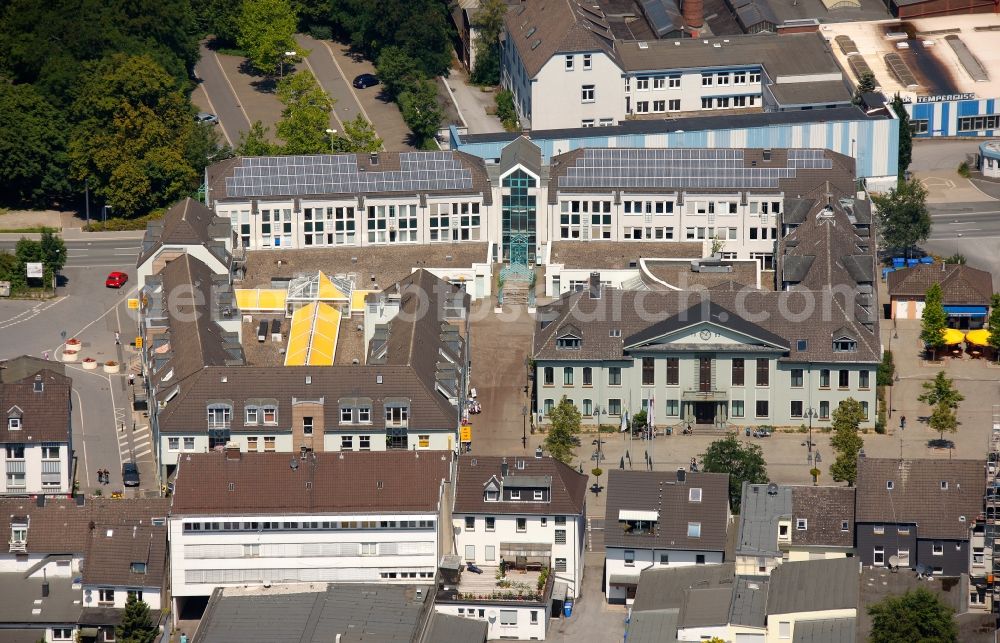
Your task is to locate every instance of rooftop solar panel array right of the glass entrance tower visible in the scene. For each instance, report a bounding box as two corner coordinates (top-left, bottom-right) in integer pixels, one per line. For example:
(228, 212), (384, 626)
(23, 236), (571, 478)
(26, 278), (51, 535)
(559, 148), (800, 188)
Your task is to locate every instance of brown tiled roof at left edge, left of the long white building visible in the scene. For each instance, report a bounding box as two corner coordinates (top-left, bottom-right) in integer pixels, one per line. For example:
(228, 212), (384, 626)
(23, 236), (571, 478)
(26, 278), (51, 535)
(0, 497), (170, 554)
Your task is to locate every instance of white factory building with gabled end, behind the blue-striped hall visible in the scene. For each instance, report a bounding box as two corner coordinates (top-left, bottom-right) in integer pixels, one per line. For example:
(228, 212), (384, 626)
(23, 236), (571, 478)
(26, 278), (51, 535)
(500, 0), (851, 129)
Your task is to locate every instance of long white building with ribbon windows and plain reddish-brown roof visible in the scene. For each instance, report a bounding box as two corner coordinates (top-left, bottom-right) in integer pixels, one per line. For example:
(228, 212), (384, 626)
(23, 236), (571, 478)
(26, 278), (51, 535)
(168, 446), (454, 614)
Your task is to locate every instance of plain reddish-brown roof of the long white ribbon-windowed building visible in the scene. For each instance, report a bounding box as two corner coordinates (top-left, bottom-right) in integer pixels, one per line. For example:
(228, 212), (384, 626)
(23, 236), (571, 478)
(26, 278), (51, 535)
(171, 451), (451, 516)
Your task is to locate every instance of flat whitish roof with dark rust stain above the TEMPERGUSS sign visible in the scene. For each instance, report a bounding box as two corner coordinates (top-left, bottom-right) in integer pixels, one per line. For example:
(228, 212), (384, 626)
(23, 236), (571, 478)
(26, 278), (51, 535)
(820, 14), (1000, 102)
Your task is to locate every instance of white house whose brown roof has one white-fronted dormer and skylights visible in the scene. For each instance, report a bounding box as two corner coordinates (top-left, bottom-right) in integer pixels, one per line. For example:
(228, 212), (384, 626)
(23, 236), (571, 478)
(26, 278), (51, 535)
(604, 469), (732, 604)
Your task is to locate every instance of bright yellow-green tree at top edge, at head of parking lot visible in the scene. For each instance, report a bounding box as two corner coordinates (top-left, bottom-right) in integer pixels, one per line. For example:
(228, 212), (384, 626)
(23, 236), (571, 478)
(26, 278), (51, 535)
(236, 0), (300, 75)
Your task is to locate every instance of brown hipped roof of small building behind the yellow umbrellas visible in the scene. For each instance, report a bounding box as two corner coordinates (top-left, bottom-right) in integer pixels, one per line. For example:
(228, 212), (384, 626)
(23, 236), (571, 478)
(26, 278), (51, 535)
(888, 263), (993, 306)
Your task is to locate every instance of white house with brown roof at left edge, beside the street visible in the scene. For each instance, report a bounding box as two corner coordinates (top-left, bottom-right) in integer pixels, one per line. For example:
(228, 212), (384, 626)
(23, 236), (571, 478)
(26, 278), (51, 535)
(0, 357), (73, 495)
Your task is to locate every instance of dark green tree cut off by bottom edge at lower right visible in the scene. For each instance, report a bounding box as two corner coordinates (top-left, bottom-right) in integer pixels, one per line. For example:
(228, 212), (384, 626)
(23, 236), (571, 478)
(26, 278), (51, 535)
(868, 587), (958, 643)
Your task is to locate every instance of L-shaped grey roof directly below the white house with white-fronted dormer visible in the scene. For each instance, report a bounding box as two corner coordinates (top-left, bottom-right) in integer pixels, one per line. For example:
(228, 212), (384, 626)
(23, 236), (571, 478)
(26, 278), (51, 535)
(632, 563), (736, 613)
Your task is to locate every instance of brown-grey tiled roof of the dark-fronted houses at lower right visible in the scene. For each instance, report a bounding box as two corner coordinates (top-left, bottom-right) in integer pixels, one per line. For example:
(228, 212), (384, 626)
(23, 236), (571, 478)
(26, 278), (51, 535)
(855, 458), (986, 540)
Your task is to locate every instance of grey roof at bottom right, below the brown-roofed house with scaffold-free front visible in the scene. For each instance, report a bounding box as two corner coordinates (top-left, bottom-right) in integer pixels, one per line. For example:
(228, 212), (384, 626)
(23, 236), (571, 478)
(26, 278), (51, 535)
(767, 558), (860, 616)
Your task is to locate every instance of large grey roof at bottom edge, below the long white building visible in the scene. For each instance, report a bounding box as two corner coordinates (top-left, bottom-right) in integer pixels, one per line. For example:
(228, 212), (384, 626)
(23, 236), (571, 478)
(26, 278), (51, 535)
(196, 583), (433, 643)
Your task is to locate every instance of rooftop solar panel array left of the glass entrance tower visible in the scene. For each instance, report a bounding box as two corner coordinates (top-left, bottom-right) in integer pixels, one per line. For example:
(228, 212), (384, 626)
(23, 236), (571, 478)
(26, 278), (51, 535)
(226, 152), (472, 197)
